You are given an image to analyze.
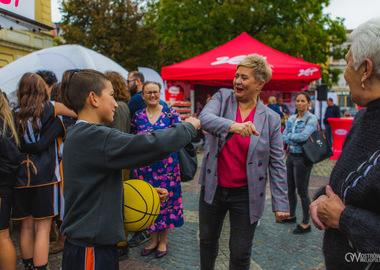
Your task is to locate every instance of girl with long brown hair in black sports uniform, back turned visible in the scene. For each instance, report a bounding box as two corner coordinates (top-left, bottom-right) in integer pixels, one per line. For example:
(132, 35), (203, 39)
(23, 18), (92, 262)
(12, 73), (76, 270)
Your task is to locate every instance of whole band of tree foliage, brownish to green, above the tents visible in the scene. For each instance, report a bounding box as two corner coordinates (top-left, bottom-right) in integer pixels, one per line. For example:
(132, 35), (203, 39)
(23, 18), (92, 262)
(62, 0), (346, 83)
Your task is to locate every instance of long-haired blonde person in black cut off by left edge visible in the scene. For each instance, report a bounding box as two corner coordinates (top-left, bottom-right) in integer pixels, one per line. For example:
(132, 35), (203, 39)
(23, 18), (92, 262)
(0, 90), (20, 269)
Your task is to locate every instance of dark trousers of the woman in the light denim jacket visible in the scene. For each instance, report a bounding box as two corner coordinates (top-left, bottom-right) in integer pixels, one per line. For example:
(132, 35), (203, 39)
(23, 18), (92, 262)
(286, 153), (313, 224)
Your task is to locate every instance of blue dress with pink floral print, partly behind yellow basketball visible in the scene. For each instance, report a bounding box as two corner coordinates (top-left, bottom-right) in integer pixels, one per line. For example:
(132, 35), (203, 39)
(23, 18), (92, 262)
(131, 106), (183, 232)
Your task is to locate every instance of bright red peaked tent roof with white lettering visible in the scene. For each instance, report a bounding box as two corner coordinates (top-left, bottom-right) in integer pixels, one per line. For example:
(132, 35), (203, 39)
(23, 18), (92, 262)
(161, 33), (321, 91)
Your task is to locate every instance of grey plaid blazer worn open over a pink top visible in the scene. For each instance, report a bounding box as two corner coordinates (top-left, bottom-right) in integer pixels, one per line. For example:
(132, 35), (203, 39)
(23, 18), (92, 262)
(199, 88), (289, 223)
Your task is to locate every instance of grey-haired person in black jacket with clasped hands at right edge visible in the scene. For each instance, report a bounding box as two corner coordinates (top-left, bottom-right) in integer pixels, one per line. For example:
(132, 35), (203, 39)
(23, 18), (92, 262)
(310, 18), (380, 270)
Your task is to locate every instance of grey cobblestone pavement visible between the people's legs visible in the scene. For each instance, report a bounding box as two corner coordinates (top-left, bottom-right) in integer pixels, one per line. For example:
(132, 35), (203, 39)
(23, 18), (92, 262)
(12, 154), (335, 270)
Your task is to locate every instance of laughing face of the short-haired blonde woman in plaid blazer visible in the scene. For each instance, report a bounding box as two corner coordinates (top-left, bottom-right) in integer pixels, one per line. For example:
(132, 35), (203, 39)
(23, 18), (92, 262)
(233, 66), (264, 102)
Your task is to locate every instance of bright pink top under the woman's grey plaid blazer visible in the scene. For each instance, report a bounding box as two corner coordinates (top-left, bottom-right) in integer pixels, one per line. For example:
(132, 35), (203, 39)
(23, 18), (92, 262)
(218, 106), (256, 188)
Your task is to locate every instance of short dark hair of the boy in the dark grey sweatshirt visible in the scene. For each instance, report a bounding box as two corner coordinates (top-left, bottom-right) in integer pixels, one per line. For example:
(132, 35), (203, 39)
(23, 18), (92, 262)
(61, 69), (109, 114)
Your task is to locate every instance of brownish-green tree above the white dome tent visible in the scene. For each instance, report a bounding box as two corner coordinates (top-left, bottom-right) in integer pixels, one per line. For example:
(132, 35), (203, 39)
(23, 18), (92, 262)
(61, 0), (159, 70)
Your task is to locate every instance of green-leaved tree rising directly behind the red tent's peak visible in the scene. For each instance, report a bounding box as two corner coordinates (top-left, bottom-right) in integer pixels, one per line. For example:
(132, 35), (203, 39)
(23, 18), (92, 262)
(147, 0), (346, 82)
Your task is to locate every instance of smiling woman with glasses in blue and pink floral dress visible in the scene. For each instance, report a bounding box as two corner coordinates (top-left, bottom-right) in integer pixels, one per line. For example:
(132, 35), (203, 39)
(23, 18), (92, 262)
(131, 82), (183, 258)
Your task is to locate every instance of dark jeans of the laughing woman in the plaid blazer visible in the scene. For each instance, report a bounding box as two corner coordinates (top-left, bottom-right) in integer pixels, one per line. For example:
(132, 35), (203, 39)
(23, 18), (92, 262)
(199, 186), (257, 270)
